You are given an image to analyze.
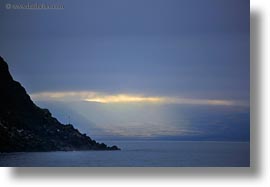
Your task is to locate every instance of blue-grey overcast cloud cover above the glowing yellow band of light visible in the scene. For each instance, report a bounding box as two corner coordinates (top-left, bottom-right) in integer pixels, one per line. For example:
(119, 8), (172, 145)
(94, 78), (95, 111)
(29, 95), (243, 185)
(0, 0), (250, 140)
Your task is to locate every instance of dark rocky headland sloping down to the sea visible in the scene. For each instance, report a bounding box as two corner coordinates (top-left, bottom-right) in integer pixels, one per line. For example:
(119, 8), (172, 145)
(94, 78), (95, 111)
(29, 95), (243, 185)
(0, 57), (119, 152)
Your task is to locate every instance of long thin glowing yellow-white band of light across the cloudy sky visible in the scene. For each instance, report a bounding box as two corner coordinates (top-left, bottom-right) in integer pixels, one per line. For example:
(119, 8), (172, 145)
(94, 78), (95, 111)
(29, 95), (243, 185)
(31, 91), (249, 106)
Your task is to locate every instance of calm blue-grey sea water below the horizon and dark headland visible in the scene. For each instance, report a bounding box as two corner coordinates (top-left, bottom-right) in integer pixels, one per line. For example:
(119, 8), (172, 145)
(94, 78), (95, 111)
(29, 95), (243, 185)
(0, 141), (250, 167)
